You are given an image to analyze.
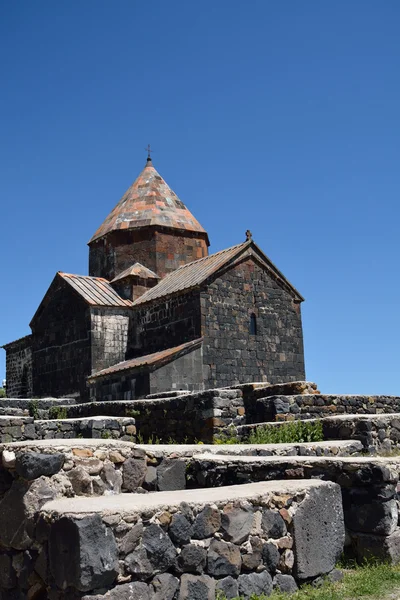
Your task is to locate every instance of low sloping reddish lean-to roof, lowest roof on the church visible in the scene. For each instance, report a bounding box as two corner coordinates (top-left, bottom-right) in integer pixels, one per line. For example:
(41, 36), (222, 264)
(88, 338), (203, 382)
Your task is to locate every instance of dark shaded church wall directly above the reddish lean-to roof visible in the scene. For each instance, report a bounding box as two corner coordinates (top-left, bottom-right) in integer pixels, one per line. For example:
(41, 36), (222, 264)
(128, 292), (201, 358)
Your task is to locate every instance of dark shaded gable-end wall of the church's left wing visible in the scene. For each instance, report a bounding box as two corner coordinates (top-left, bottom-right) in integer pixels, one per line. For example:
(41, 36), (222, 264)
(32, 278), (91, 398)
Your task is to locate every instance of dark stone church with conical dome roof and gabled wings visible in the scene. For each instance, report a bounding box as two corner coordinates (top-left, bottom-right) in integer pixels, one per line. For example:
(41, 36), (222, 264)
(4, 157), (305, 400)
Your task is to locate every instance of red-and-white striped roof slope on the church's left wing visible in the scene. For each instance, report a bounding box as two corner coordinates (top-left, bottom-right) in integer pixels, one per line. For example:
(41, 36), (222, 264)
(57, 271), (132, 307)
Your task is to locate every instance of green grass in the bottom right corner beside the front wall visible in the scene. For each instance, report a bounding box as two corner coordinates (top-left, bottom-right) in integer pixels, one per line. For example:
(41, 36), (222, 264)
(219, 563), (400, 600)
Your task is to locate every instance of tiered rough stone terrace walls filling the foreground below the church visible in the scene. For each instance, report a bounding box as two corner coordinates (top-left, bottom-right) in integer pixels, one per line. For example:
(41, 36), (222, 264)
(0, 382), (400, 600)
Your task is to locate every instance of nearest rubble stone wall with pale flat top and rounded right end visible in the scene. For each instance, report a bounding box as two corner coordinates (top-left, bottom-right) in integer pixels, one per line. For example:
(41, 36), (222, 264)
(34, 481), (344, 600)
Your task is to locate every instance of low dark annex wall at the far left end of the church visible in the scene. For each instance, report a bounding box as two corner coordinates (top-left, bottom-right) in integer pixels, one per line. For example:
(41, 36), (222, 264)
(5, 335), (32, 398)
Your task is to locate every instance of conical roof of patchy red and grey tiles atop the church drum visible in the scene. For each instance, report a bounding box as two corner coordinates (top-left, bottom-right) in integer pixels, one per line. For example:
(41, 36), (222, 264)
(89, 159), (208, 243)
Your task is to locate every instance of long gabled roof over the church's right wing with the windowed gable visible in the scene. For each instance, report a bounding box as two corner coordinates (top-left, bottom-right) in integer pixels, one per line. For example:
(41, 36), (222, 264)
(133, 240), (304, 306)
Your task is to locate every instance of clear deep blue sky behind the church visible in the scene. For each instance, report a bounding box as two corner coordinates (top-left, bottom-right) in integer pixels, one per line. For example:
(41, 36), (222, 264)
(0, 0), (400, 394)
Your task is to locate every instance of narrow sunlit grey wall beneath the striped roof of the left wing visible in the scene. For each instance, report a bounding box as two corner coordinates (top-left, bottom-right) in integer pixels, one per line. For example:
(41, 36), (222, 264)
(90, 308), (130, 373)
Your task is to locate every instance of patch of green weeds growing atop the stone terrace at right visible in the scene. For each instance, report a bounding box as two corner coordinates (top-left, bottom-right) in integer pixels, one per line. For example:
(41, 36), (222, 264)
(246, 421), (324, 444)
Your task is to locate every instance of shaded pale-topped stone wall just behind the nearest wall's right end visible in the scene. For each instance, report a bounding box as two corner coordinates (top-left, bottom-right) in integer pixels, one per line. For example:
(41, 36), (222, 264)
(186, 454), (400, 562)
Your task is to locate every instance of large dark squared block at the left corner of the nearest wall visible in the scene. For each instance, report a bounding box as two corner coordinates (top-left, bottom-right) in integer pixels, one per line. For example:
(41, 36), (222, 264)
(49, 515), (118, 592)
